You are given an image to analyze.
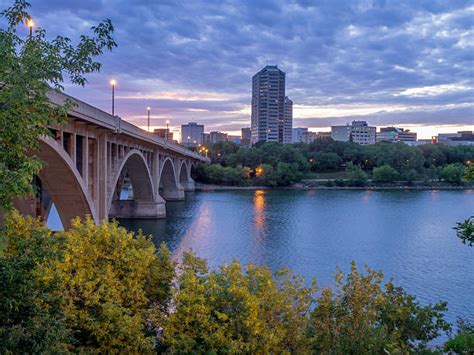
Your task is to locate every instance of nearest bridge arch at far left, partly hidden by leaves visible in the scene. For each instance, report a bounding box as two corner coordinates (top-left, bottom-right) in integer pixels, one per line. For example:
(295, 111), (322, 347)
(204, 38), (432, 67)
(15, 137), (99, 229)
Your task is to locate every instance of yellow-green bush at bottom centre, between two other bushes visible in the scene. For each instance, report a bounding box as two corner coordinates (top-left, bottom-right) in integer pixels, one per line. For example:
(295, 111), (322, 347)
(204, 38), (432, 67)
(157, 254), (315, 353)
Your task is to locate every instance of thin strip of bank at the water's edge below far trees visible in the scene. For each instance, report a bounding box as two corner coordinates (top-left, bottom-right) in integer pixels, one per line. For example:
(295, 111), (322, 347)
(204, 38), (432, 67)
(195, 183), (474, 192)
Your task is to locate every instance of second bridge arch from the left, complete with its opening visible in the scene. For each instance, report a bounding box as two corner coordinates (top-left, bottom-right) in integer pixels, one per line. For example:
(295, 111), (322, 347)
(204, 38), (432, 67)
(107, 149), (164, 218)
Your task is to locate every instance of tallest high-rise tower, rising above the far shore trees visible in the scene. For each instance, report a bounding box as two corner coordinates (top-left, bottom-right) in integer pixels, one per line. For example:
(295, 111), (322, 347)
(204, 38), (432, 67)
(251, 65), (292, 144)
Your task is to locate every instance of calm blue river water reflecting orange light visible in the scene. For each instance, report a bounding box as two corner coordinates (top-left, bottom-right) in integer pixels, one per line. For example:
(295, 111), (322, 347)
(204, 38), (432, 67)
(120, 190), (474, 330)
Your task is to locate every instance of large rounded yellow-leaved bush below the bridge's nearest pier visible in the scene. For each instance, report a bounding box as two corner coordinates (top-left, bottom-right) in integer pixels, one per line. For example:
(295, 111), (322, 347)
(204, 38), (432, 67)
(55, 218), (174, 353)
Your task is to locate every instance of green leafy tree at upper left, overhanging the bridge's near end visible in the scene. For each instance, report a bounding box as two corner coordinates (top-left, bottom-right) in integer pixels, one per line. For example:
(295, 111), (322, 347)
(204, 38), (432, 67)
(0, 0), (116, 210)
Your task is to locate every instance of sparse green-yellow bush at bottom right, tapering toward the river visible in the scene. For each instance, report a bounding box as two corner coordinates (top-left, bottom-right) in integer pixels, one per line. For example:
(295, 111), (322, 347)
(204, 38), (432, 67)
(309, 263), (450, 354)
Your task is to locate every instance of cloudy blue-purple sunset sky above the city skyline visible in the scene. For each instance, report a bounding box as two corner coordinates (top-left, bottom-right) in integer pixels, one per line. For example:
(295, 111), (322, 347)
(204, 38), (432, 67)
(0, 0), (474, 138)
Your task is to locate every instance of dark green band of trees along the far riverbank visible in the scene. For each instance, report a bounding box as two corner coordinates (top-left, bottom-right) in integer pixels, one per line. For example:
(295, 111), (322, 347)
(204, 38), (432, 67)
(194, 137), (474, 187)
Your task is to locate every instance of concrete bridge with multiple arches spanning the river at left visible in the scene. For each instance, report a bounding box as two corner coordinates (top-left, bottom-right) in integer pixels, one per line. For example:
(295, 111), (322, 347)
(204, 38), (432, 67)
(15, 89), (209, 228)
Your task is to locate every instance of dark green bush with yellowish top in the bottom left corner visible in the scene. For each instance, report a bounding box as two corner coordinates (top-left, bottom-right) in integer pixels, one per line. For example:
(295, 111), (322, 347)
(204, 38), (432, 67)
(0, 212), (69, 354)
